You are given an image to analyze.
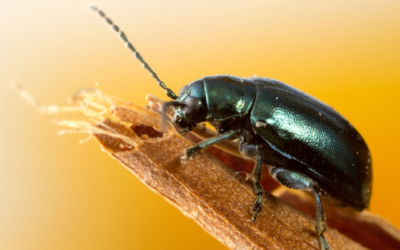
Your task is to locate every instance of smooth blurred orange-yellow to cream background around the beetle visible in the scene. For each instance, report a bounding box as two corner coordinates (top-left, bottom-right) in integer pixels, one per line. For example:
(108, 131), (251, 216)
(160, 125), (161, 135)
(0, 0), (400, 250)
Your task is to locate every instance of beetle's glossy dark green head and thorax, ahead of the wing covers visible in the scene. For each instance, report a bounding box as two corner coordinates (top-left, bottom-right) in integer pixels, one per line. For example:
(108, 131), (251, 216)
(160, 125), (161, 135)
(173, 75), (256, 130)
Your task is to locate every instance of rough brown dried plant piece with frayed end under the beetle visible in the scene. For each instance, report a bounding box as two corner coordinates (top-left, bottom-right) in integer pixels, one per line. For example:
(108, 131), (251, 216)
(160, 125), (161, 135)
(95, 102), (365, 250)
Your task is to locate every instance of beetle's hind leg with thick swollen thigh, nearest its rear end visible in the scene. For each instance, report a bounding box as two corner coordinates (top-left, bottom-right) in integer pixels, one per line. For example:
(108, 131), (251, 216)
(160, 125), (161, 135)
(270, 167), (329, 250)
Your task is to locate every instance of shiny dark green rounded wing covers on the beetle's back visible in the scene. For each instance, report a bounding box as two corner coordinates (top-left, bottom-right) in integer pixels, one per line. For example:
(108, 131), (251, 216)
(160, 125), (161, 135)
(251, 78), (372, 210)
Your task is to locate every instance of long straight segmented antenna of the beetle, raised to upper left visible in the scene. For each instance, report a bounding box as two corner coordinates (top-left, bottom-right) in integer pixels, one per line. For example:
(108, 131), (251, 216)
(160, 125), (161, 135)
(89, 6), (178, 100)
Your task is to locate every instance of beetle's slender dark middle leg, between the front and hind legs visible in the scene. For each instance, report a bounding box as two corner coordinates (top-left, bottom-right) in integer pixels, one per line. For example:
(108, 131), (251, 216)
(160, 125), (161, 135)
(246, 153), (264, 222)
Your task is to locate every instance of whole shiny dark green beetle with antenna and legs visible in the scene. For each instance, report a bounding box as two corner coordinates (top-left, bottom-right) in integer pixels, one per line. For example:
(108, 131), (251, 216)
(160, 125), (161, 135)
(90, 6), (372, 250)
